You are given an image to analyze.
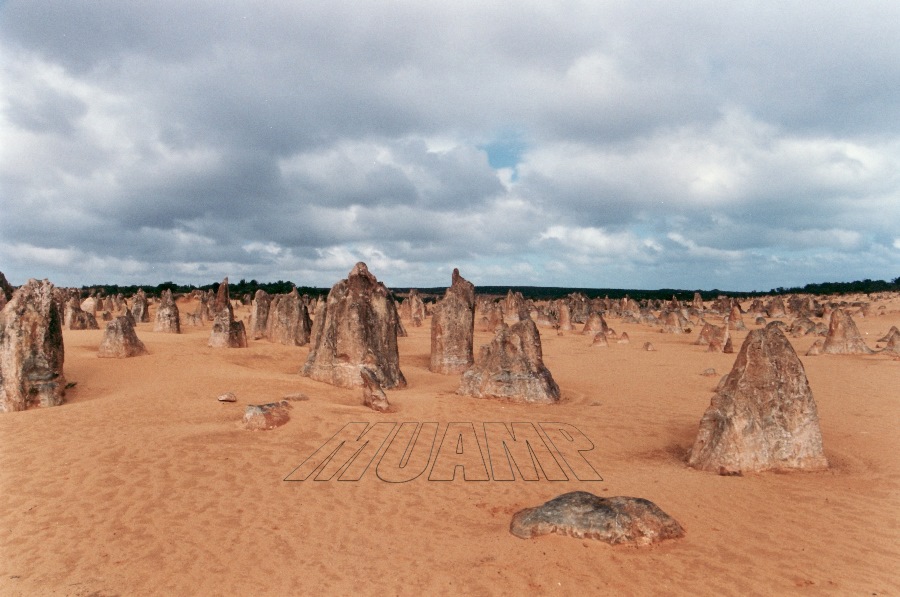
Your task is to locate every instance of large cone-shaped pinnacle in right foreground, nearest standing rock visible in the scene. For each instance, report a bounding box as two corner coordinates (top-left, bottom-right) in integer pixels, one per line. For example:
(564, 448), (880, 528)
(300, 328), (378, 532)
(688, 324), (828, 474)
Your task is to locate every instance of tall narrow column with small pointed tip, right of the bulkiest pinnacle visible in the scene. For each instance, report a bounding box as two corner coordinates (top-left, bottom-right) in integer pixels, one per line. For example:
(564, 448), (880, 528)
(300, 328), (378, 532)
(428, 269), (475, 375)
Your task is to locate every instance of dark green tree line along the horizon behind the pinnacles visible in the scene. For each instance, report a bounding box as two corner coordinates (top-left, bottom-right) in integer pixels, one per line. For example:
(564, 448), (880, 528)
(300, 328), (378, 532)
(81, 277), (900, 301)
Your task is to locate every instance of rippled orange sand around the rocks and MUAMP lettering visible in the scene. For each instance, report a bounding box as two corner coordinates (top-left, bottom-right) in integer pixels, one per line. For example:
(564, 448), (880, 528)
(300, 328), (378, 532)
(0, 292), (900, 597)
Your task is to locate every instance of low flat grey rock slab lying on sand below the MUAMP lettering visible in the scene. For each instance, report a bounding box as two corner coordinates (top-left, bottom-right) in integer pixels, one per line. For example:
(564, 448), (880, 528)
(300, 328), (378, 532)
(509, 491), (684, 545)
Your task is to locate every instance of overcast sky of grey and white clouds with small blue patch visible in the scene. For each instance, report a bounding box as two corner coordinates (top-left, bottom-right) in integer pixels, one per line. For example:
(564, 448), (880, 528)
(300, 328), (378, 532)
(0, 0), (900, 291)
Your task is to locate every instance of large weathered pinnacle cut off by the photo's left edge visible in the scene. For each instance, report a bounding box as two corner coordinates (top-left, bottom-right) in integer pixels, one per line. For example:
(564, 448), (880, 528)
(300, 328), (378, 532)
(0, 280), (66, 412)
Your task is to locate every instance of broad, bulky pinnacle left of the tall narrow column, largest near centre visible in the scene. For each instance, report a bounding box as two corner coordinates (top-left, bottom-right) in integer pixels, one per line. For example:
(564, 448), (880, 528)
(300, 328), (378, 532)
(301, 262), (406, 389)
